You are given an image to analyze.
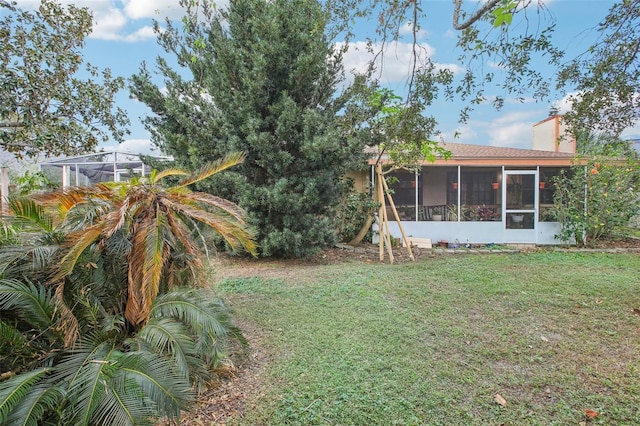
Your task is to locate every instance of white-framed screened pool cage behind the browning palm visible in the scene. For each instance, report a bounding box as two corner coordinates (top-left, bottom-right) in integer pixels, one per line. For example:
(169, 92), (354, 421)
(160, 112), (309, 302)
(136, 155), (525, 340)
(40, 151), (172, 188)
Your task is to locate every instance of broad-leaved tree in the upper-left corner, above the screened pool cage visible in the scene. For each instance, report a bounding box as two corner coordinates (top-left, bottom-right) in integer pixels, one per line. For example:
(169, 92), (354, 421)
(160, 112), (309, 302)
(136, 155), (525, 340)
(0, 0), (128, 158)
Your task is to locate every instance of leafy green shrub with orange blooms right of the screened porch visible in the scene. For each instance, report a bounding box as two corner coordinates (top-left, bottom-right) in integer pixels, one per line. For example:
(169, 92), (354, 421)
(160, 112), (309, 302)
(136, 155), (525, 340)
(553, 157), (640, 245)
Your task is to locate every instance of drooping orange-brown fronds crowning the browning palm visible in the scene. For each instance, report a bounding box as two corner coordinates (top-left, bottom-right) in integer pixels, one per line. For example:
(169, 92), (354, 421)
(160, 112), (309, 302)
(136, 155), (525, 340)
(38, 154), (256, 326)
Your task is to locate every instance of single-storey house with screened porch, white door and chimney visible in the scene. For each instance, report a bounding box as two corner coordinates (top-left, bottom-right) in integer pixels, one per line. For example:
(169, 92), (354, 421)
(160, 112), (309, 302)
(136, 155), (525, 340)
(362, 116), (575, 245)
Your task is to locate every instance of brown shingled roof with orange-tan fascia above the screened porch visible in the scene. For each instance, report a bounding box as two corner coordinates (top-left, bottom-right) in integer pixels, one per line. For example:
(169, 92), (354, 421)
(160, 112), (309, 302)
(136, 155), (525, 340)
(370, 142), (575, 166)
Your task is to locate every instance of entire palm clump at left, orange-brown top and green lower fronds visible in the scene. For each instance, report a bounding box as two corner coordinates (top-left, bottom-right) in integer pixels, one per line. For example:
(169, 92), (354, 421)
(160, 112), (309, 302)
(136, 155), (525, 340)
(0, 154), (256, 425)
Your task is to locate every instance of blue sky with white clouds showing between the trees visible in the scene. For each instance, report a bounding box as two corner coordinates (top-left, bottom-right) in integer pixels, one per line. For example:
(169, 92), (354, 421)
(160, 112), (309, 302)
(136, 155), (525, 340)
(5, 0), (640, 160)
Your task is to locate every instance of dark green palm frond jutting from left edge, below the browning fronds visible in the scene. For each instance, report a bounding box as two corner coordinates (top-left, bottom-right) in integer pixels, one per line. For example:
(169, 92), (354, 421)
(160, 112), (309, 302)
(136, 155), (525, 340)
(0, 279), (56, 332)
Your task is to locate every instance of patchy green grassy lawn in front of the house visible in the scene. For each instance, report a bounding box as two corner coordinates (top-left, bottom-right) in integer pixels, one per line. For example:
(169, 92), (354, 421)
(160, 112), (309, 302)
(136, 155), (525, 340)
(217, 252), (640, 425)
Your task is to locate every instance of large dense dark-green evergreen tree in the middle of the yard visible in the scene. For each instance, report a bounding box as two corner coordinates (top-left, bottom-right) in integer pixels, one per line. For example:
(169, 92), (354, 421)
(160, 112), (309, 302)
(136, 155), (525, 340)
(131, 0), (364, 257)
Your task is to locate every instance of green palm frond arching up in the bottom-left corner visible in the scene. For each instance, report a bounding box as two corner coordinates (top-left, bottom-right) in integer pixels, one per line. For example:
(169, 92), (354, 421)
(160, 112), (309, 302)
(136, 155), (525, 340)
(7, 382), (64, 426)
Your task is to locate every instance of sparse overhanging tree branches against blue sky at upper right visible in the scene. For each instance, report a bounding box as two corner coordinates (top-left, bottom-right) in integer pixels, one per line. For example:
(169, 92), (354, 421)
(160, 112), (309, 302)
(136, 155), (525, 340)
(356, 0), (640, 136)
